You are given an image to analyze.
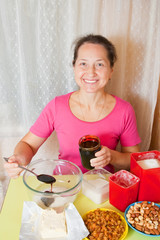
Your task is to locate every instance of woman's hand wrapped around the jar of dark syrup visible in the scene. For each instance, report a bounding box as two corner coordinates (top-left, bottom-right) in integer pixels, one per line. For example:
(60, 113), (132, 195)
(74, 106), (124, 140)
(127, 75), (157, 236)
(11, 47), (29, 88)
(90, 146), (111, 168)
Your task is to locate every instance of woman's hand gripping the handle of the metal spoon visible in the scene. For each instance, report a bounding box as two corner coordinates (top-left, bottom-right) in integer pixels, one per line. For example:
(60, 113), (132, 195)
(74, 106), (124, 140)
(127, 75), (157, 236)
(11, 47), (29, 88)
(4, 155), (23, 179)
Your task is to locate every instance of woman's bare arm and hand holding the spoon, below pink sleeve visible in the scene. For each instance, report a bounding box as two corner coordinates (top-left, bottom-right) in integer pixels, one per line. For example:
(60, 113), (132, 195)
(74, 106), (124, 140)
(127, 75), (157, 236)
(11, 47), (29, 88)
(4, 132), (46, 178)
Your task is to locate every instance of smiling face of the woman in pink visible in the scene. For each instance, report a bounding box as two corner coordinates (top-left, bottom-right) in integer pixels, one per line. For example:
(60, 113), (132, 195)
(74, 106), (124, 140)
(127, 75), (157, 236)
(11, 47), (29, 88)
(74, 43), (113, 93)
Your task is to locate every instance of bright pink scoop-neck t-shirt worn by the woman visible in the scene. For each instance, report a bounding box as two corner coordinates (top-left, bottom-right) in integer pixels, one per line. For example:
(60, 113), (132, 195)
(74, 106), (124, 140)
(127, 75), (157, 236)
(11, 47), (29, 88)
(30, 93), (141, 172)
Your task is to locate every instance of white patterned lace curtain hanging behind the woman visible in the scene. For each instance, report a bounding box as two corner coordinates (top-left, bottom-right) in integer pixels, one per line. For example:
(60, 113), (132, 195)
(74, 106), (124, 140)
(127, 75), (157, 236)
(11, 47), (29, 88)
(0, 0), (160, 168)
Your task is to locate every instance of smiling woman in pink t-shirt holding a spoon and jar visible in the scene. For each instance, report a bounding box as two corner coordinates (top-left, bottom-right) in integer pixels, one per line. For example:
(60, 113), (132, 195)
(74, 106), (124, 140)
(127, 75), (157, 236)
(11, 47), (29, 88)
(5, 35), (140, 178)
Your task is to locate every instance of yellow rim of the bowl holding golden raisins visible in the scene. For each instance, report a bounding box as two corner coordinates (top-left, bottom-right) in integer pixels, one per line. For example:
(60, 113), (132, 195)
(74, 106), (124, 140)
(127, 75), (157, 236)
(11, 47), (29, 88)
(83, 208), (128, 240)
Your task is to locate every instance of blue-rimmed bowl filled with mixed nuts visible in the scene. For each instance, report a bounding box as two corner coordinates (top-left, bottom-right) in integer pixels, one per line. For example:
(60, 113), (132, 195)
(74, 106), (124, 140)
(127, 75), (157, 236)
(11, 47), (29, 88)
(125, 201), (160, 237)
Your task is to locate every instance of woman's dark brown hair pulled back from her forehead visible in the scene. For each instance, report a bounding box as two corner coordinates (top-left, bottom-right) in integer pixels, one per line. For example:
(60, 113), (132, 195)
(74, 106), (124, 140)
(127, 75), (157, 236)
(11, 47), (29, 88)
(72, 34), (117, 67)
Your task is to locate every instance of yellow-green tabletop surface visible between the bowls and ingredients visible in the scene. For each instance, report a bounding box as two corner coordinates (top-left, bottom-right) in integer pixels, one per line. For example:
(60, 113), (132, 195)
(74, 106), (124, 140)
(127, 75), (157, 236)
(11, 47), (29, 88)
(0, 177), (160, 240)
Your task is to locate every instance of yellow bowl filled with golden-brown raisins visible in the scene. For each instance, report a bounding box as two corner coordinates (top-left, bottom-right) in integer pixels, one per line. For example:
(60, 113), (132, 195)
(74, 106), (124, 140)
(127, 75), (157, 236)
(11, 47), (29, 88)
(83, 208), (128, 240)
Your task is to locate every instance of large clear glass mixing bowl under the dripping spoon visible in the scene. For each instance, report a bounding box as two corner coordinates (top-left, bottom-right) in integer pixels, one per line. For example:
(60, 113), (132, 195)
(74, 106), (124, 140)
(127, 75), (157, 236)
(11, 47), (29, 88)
(23, 159), (83, 211)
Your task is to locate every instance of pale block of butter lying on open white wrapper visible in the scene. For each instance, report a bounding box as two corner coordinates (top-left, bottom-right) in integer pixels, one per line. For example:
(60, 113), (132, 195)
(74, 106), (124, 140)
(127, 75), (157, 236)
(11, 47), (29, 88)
(39, 209), (67, 240)
